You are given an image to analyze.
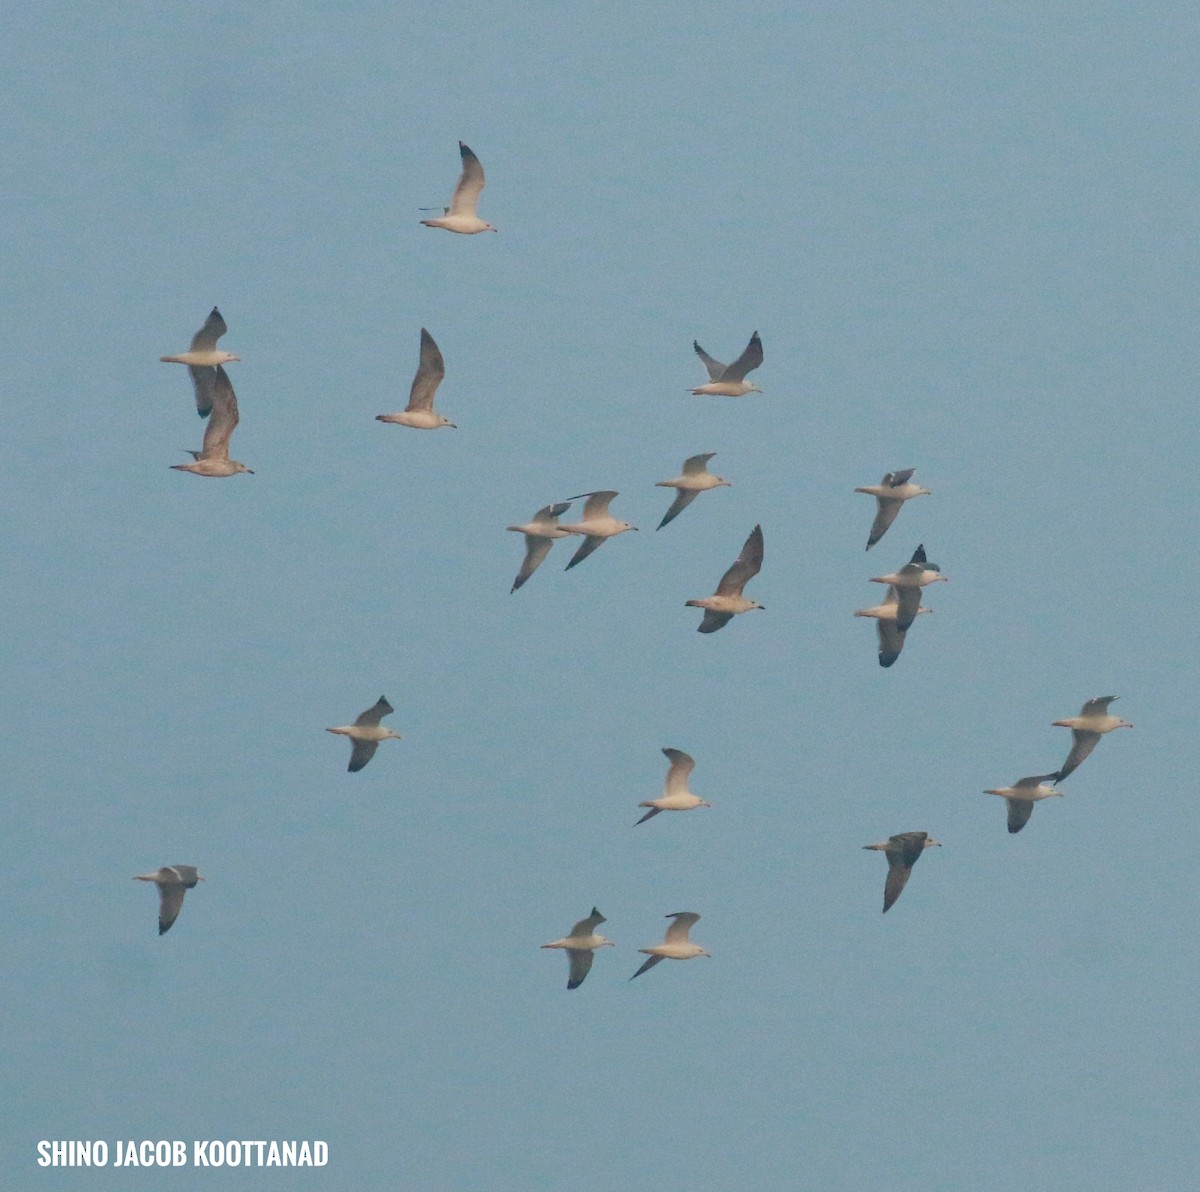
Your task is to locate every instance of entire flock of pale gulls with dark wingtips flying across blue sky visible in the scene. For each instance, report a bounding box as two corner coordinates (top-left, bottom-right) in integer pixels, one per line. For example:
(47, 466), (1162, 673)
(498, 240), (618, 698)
(142, 142), (1133, 969)
